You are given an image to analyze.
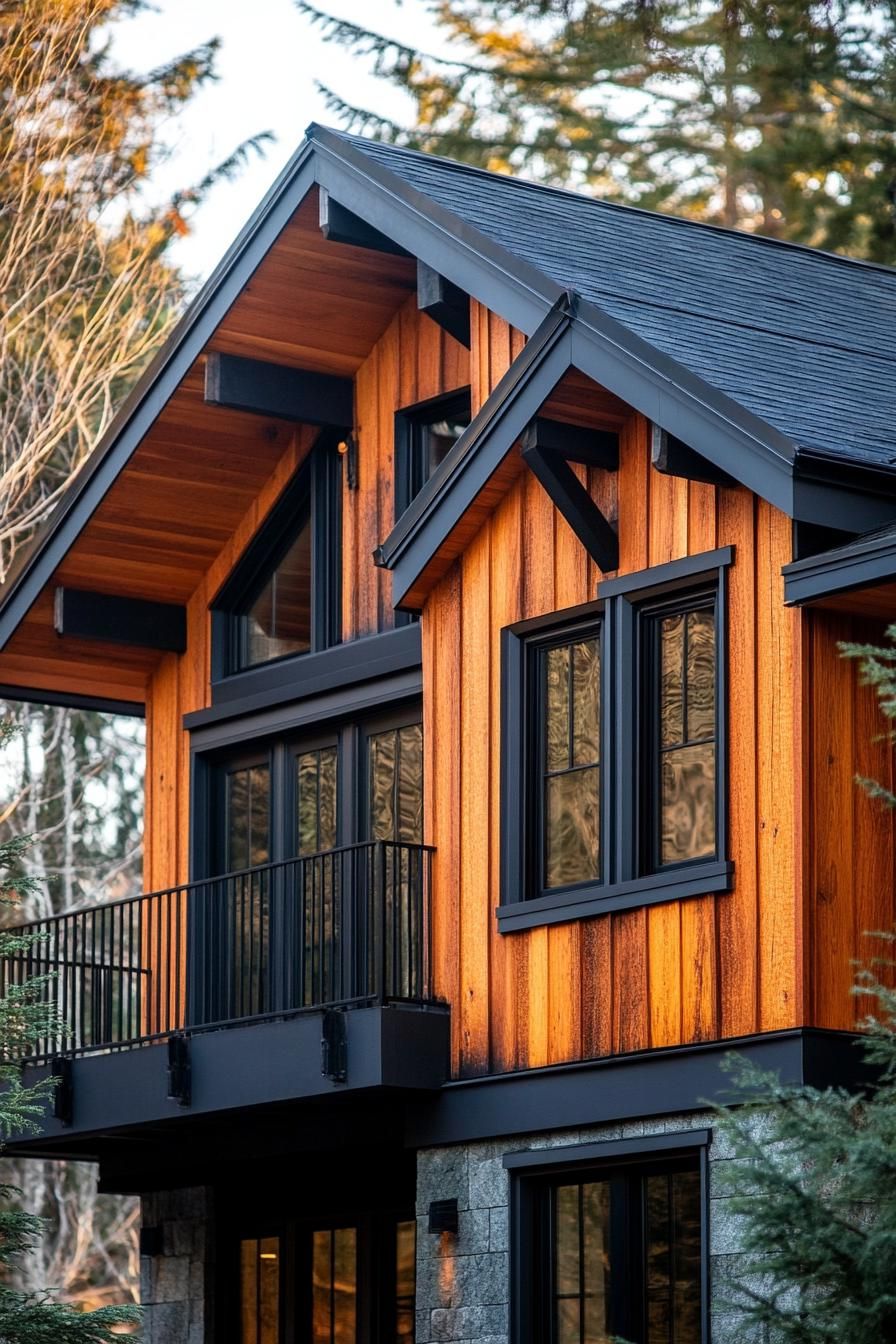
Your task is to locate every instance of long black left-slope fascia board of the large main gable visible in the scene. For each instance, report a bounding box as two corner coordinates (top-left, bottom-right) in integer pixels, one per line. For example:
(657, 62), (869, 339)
(0, 144), (314, 649)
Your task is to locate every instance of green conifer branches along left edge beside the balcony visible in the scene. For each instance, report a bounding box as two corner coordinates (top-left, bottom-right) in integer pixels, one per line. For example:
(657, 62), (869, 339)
(0, 720), (140, 1344)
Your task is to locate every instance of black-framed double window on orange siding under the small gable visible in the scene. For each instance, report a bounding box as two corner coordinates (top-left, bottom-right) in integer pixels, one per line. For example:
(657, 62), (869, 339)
(498, 547), (733, 931)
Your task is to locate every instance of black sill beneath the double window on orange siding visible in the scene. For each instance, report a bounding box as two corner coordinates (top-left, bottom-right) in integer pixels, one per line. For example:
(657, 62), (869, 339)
(496, 859), (735, 933)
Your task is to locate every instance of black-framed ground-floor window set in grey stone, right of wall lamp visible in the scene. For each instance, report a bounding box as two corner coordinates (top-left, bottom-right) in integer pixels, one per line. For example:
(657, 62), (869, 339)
(505, 1130), (708, 1344)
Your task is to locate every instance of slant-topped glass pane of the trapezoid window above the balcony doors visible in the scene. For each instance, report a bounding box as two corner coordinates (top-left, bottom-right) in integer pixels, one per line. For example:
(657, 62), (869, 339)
(243, 512), (312, 667)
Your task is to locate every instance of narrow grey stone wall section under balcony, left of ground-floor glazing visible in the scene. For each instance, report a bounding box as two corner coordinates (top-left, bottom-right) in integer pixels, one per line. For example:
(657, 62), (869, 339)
(140, 1185), (215, 1344)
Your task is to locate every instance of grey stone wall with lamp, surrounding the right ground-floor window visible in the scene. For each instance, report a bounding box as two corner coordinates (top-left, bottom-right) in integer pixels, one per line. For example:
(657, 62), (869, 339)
(416, 1113), (762, 1344)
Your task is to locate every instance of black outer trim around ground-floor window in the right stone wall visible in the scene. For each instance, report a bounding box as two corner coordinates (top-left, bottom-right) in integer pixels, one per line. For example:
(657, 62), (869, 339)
(502, 1129), (712, 1344)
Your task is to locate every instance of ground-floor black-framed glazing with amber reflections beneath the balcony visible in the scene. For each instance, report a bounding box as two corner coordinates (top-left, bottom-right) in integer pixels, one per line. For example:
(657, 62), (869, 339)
(236, 1214), (416, 1344)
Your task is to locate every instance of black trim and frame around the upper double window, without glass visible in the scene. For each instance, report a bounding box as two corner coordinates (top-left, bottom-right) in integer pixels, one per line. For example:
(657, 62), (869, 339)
(496, 546), (735, 933)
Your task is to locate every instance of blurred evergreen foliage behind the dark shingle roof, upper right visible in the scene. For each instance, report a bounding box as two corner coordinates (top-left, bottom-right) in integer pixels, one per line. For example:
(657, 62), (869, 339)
(297, 0), (896, 262)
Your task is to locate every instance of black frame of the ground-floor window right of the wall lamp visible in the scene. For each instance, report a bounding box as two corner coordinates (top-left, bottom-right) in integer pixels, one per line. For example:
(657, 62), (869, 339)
(504, 1129), (712, 1344)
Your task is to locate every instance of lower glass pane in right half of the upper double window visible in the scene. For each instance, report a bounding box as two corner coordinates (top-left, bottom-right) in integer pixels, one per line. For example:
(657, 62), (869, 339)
(661, 742), (716, 863)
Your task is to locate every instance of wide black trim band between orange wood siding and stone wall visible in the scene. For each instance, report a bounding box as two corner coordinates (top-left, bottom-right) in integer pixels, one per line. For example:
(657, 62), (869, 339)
(406, 1027), (873, 1148)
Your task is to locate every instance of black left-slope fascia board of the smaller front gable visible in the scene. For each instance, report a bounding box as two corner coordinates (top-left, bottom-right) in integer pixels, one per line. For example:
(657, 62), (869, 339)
(375, 294), (571, 603)
